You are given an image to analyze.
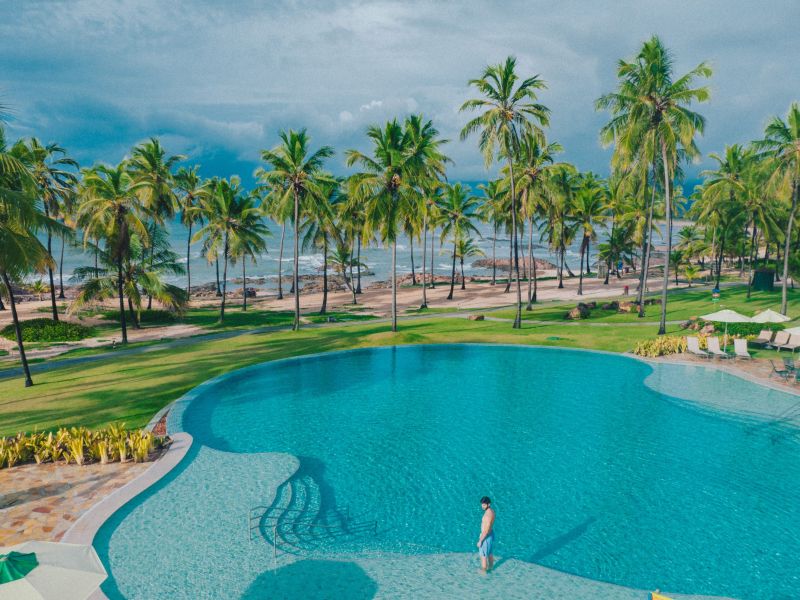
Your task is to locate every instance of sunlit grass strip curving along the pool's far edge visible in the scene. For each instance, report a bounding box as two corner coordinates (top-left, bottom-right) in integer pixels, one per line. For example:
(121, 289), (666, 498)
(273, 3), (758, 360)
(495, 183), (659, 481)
(0, 318), (688, 435)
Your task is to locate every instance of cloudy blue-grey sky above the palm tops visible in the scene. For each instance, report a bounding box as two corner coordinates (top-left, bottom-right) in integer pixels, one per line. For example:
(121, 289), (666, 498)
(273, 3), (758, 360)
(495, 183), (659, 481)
(0, 0), (800, 185)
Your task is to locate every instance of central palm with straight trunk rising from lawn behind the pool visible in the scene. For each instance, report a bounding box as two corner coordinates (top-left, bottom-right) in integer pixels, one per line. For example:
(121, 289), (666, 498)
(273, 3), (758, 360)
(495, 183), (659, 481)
(345, 119), (441, 331)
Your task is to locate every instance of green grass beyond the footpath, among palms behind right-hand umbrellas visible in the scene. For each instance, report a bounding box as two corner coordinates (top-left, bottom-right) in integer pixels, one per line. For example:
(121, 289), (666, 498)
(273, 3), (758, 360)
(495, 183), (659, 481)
(492, 286), (800, 323)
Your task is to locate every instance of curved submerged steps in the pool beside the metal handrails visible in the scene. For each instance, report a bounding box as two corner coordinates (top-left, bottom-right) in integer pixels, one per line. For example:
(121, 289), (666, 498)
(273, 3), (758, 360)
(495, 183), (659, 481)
(247, 473), (378, 560)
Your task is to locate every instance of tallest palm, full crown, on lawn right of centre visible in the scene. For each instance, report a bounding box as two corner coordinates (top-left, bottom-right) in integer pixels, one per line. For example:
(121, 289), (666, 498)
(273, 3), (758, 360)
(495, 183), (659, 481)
(597, 36), (711, 335)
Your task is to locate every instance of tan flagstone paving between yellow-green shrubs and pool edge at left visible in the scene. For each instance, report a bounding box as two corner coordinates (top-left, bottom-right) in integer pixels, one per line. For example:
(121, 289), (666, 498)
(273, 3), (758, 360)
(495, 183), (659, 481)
(0, 462), (152, 546)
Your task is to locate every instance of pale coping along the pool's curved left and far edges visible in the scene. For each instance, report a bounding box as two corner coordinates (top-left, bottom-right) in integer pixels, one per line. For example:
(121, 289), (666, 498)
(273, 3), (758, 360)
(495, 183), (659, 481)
(81, 342), (788, 600)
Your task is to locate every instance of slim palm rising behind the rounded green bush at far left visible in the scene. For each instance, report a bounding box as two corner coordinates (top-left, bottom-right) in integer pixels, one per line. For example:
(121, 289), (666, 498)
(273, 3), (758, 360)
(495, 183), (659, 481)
(17, 138), (78, 321)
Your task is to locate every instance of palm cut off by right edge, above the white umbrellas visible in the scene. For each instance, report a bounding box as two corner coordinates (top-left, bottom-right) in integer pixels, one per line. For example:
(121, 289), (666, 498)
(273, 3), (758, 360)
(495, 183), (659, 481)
(755, 102), (800, 315)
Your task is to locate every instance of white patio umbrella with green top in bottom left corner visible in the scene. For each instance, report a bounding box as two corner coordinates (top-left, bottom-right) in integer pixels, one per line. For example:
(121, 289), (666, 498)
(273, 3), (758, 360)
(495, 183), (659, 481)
(0, 542), (107, 600)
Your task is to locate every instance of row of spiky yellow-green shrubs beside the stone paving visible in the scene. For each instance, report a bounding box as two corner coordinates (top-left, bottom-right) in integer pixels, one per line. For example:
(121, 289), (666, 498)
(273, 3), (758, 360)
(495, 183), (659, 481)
(0, 425), (167, 469)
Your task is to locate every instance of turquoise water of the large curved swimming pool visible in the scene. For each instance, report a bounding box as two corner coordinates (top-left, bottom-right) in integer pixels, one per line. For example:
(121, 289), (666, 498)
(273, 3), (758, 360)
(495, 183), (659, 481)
(95, 345), (800, 599)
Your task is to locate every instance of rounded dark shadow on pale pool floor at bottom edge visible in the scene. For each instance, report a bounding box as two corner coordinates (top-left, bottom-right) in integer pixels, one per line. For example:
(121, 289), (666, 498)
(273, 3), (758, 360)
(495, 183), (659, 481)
(241, 560), (378, 600)
